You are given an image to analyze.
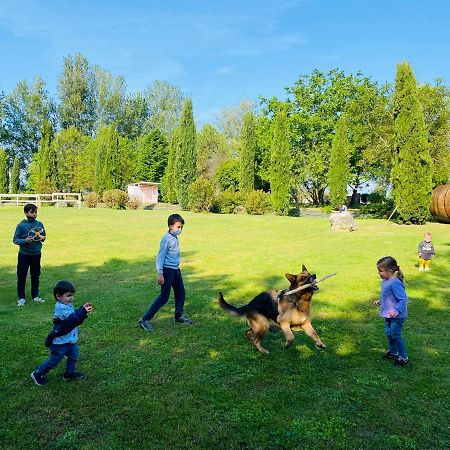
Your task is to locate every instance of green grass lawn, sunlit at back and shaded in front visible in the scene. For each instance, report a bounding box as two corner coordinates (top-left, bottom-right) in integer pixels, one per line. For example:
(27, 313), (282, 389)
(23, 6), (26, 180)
(0, 207), (450, 449)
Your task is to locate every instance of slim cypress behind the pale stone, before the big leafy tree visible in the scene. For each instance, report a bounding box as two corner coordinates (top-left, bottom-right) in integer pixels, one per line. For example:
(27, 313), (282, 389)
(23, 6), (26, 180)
(328, 116), (350, 207)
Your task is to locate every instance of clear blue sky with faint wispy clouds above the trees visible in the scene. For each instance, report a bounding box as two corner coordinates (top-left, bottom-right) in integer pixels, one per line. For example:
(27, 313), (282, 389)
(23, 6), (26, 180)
(0, 0), (450, 125)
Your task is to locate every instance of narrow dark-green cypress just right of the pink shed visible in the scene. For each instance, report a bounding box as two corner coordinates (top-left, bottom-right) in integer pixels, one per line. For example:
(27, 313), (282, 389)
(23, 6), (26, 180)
(175, 99), (197, 209)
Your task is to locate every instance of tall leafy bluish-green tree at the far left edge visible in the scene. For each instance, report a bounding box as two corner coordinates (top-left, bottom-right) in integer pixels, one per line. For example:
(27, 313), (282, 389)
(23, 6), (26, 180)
(0, 77), (54, 166)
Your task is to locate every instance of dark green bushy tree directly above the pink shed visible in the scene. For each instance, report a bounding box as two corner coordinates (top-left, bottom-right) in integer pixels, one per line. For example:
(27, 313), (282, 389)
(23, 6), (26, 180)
(136, 130), (168, 182)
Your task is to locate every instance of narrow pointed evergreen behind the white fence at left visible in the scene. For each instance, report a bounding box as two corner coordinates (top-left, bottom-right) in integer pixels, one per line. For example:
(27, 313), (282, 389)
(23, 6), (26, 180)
(36, 120), (58, 193)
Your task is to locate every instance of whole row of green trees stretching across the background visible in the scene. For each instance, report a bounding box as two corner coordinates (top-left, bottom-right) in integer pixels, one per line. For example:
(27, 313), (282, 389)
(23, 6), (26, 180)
(0, 54), (450, 223)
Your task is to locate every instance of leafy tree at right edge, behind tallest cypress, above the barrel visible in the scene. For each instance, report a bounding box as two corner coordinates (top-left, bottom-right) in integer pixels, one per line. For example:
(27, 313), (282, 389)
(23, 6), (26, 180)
(419, 79), (450, 187)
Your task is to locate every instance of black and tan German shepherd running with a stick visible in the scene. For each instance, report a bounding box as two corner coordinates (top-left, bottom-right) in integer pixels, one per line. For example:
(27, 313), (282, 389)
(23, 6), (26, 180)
(218, 266), (325, 353)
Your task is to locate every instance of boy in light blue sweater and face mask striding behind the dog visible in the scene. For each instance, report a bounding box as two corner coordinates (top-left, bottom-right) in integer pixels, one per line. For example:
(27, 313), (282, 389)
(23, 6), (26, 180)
(139, 214), (192, 331)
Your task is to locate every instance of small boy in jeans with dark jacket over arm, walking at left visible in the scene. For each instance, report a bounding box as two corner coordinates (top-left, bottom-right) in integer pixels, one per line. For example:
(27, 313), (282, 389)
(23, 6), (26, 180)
(31, 280), (92, 386)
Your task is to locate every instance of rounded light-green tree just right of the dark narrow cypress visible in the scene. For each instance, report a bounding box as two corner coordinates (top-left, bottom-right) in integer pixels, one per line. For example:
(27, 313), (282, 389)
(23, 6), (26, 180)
(197, 124), (229, 179)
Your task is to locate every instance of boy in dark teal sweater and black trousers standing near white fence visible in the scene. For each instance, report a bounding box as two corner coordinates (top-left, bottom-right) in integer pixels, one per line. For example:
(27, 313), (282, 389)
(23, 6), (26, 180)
(13, 203), (45, 306)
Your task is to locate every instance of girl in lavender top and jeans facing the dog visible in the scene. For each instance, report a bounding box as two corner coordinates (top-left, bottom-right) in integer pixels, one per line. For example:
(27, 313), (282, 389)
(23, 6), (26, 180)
(373, 256), (408, 366)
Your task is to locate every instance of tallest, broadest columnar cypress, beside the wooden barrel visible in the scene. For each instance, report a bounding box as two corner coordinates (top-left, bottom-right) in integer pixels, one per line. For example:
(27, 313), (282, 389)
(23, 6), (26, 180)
(391, 63), (432, 224)
